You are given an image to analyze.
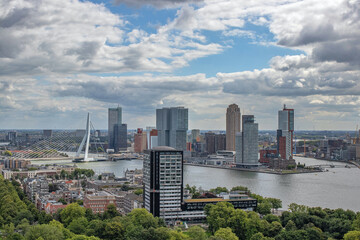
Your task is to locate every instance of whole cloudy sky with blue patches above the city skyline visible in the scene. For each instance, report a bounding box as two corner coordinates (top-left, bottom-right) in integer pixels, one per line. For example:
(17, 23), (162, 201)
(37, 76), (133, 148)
(0, 0), (360, 130)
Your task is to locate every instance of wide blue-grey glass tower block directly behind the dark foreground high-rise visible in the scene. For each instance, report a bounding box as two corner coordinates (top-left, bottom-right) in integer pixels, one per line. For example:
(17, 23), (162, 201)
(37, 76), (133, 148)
(156, 107), (188, 151)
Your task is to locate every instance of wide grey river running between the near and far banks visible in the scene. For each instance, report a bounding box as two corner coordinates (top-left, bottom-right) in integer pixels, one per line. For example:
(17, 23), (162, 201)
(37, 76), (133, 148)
(32, 157), (360, 211)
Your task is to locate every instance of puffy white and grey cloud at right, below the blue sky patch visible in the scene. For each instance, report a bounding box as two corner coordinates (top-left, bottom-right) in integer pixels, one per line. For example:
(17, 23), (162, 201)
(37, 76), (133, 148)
(221, 55), (360, 96)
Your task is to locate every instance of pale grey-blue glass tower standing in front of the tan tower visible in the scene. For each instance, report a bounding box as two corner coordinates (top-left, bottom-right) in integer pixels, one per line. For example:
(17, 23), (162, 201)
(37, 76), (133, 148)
(236, 115), (259, 167)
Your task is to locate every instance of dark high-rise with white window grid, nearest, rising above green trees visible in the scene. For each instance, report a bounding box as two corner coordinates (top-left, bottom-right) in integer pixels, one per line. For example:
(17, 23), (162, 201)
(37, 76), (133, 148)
(143, 146), (184, 222)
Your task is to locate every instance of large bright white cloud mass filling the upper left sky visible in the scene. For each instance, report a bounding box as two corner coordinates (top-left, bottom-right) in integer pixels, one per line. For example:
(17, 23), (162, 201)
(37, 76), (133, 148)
(0, 0), (222, 76)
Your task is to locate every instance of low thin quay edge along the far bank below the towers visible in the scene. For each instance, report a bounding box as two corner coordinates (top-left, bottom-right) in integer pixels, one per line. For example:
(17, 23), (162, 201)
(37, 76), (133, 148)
(184, 163), (323, 175)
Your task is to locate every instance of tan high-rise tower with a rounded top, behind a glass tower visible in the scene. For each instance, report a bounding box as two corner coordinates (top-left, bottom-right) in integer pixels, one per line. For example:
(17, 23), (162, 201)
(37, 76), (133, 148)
(226, 104), (241, 151)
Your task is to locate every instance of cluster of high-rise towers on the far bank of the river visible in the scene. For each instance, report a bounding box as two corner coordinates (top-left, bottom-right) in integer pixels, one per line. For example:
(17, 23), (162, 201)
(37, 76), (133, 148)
(108, 103), (294, 171)
